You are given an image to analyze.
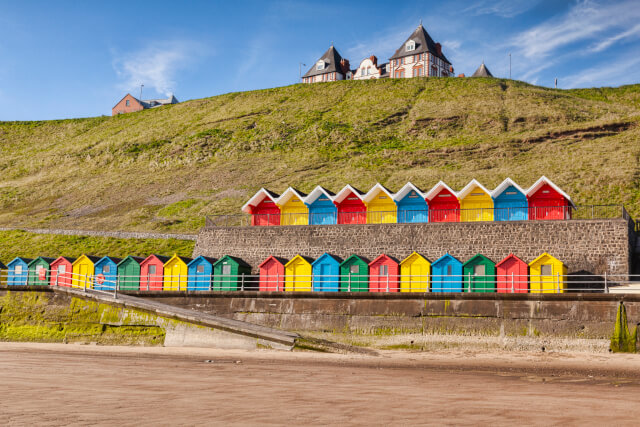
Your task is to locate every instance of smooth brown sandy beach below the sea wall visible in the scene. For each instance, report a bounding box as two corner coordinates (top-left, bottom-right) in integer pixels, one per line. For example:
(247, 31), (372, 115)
(0, 343), (640, 425)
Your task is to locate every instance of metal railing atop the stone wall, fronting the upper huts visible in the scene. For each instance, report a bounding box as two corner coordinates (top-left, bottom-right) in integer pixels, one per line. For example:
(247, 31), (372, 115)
(205, 205), (638, 231)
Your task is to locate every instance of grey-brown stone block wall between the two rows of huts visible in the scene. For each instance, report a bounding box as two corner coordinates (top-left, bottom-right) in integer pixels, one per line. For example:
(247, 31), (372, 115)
(193, 219), (633, 275)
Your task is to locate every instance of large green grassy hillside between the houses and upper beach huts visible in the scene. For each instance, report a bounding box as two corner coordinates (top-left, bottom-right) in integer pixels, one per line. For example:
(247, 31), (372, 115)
(0, 78), (640, 231)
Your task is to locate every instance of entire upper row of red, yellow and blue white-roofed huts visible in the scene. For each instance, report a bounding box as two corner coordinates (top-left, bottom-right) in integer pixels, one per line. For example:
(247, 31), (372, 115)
(242, 176), (575, 225)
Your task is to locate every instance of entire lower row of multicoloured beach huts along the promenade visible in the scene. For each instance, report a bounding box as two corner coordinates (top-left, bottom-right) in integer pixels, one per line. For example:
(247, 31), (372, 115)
(0, 252), (567, 293)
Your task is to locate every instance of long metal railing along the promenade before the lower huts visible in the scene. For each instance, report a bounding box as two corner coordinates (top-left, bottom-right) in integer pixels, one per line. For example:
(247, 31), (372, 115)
(5, 270), (640, 298)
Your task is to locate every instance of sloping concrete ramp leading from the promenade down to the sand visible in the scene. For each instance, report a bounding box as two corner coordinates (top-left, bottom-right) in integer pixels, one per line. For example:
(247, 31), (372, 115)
(51, 287), (299, 350)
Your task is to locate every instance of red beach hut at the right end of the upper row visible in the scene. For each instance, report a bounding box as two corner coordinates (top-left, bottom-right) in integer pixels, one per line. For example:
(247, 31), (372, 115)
(526, 176), (575, 220)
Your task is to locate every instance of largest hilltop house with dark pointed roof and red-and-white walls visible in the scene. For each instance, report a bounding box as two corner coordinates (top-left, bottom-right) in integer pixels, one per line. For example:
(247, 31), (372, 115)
(389, 24), (453, 78)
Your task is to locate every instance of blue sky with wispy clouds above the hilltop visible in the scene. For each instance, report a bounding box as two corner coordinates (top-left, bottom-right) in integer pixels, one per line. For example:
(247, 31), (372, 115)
(0, 0), (640, 120)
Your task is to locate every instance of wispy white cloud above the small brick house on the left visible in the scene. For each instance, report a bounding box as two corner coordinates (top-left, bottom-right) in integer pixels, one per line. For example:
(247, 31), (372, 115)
(113, 40), (206, 95)
